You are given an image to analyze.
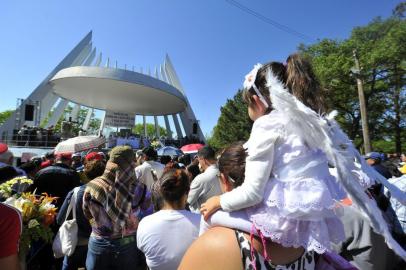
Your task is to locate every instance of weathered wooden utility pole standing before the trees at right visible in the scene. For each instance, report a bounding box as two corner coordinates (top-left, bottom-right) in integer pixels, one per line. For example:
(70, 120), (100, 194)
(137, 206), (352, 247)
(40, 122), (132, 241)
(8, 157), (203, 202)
(353, 50), (371, 153)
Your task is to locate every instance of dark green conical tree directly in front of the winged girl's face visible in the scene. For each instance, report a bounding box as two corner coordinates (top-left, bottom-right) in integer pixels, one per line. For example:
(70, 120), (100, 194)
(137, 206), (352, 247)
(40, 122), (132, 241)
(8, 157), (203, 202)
(208, 90), (252, 150)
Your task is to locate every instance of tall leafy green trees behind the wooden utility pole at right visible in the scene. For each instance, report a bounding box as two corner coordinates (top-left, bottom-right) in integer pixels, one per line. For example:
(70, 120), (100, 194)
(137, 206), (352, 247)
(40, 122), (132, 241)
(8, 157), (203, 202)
(299, 16), (406, 152)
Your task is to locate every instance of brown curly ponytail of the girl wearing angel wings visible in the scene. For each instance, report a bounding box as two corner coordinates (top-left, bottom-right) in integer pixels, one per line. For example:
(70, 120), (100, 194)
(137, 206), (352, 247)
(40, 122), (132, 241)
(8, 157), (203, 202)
(286, 53), (327, 114)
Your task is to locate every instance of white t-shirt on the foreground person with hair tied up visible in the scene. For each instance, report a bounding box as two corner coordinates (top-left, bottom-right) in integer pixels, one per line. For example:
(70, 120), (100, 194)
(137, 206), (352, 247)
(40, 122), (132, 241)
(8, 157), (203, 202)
(137, 210), (200, 270)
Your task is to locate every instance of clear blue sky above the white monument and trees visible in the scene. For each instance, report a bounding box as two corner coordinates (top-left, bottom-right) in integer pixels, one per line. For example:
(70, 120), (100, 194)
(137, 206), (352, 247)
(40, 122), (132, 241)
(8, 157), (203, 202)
(0, 0), (400, 134)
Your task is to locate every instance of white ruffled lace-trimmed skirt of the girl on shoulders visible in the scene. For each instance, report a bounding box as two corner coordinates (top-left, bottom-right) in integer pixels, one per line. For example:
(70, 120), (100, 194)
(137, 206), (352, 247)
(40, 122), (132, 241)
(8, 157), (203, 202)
(246, 163), (345, 254)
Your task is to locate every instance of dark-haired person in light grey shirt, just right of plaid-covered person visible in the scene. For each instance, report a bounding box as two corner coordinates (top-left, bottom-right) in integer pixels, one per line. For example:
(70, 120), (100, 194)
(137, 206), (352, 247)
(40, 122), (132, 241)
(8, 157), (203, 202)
(135, 147), (165, 191)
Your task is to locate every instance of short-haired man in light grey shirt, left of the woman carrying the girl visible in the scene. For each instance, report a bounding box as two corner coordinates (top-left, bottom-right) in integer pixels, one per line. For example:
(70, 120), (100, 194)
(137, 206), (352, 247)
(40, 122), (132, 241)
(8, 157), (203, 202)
(187, 146), (222, 213)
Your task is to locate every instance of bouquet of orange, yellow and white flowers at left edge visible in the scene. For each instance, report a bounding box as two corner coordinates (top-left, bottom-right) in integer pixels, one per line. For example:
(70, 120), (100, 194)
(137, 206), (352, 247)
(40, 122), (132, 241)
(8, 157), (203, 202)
(5, 192), (56, 256)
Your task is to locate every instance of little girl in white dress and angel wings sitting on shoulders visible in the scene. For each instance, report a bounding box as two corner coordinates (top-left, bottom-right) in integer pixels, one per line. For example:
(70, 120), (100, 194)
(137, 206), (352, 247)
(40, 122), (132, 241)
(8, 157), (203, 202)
(201, 54), (406, 258)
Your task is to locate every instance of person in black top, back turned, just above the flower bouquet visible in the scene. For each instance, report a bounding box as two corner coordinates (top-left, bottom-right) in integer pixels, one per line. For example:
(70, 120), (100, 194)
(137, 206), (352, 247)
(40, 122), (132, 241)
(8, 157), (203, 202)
(30, 154), (81, 208)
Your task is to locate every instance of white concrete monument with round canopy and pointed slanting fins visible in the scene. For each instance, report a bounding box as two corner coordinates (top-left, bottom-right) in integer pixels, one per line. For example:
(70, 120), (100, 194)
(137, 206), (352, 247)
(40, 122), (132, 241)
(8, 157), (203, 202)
(0, 32), (205, 141)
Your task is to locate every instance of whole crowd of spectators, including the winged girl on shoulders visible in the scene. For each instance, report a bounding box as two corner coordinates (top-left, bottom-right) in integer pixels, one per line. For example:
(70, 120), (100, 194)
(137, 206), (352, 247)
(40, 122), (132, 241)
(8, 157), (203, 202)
(0, 51), (406, 270)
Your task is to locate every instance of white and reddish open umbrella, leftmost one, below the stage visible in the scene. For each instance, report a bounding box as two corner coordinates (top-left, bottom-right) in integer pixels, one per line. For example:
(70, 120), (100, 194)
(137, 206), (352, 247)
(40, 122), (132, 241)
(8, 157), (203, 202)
(55, 136), (106, 154)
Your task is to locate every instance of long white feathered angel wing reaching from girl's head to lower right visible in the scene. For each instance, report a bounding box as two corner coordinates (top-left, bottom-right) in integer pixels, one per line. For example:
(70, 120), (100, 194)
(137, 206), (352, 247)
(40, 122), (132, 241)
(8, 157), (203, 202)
(268, 70), (406, 260)
